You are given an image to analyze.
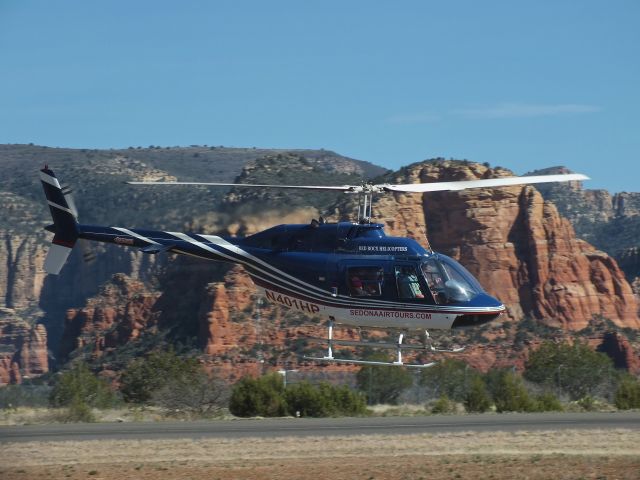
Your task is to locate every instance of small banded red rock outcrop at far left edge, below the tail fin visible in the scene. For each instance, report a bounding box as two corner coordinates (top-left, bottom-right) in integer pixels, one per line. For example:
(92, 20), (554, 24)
(0, 309), (49, 386)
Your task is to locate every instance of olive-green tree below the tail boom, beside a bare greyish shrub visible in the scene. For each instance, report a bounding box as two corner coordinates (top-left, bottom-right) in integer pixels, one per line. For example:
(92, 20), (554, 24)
(120, 350), (202, 403)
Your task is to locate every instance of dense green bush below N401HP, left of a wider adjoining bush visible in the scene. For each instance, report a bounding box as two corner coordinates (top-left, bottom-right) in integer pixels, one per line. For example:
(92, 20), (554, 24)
(229, 373), (287, 417)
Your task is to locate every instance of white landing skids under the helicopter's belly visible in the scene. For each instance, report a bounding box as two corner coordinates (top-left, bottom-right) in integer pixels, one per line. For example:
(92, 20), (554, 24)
(302, 319), (464, 368)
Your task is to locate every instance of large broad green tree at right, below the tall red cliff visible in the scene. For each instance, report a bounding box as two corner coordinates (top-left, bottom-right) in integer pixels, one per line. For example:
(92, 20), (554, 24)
(524, 341), (615, 400)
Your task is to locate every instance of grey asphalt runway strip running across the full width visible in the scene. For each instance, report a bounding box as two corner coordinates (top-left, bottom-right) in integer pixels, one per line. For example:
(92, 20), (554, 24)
(0, 412), (640, 443)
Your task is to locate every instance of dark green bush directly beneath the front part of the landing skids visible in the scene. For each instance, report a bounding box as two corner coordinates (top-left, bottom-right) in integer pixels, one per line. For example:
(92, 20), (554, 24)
(356, 353), (413, 405)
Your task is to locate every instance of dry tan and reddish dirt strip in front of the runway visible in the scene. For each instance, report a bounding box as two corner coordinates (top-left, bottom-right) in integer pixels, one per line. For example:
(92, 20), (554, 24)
(0, 429), (640, 480)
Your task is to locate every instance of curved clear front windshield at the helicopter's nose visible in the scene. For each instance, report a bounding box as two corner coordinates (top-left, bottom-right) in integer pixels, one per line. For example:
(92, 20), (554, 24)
(422, 254), (482, 304)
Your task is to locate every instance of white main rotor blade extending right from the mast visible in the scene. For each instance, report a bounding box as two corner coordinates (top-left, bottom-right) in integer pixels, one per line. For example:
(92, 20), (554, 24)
(380, 173), (589, 193)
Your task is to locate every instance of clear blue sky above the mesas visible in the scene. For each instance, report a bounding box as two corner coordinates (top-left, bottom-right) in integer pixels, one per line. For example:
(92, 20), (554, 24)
(0, 0), (640, 191)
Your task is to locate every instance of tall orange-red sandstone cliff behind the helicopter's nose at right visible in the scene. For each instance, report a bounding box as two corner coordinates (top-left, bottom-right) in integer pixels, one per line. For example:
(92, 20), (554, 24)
(377, 161), (640, 330)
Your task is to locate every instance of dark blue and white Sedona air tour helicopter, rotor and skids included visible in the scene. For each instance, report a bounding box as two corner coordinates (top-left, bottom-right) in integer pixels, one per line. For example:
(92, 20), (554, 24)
(40, 165), (589, 368)
